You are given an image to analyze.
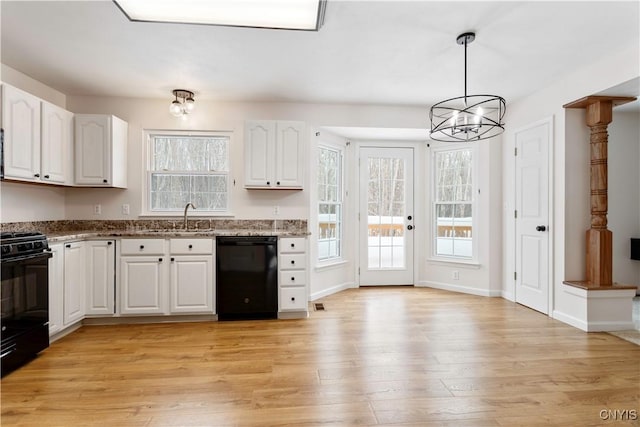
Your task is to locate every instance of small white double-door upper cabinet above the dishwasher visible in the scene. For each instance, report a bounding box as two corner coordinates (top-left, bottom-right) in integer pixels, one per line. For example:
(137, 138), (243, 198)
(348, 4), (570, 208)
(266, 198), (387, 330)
(244, 120), (306, 190)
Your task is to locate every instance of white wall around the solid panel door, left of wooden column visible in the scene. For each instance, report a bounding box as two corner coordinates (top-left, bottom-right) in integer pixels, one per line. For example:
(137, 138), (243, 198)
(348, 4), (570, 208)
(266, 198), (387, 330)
(503, 40), (640, 321)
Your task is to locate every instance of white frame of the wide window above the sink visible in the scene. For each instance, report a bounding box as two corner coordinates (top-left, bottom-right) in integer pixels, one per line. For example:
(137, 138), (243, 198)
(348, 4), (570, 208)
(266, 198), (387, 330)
(140, 129), (234, 217)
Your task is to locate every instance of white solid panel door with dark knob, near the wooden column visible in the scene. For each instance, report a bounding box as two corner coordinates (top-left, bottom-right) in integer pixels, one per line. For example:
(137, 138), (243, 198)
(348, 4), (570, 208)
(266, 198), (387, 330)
(515, 122), (551, 314)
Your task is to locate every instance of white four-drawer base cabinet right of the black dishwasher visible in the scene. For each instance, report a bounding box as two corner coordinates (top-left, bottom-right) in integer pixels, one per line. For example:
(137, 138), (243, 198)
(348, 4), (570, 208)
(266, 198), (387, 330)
(278, 237), (308, 315)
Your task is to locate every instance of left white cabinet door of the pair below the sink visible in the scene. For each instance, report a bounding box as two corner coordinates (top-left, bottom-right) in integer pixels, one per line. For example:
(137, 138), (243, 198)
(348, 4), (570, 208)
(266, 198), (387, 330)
(118, 256), (167, 314)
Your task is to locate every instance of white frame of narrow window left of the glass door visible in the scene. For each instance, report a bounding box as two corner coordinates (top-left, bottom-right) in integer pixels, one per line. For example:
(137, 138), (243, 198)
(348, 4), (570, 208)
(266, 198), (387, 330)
(315, 142), (345, 267)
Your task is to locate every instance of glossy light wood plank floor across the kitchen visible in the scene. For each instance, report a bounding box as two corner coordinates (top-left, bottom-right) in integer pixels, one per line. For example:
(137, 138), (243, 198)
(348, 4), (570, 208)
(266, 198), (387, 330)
(1, 287), (640, 427)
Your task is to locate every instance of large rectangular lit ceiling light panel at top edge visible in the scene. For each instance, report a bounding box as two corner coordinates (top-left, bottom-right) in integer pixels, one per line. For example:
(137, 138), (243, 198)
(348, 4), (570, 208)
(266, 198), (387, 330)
(114, 0), (326, 31)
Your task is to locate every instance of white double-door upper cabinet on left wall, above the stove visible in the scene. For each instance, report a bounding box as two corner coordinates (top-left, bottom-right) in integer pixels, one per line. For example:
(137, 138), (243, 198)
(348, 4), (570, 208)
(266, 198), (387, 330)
(2, 84), (73, 185)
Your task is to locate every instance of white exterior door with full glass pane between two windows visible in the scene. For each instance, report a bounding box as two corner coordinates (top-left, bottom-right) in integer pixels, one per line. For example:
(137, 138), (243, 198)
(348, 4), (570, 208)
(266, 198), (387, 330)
(359, 147), (414, 286)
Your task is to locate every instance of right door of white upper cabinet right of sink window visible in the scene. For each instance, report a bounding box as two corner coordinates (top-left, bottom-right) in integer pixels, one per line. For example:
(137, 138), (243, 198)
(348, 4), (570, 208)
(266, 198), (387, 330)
(275, 121), (305, 188)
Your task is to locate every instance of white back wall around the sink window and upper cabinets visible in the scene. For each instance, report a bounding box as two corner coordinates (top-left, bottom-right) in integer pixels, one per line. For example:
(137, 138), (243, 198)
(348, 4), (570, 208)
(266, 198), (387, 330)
(60, 96), (438, 219)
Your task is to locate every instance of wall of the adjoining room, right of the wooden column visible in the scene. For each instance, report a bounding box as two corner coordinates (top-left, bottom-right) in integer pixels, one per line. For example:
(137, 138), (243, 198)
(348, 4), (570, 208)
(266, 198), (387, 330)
(608, 109), (640, 287)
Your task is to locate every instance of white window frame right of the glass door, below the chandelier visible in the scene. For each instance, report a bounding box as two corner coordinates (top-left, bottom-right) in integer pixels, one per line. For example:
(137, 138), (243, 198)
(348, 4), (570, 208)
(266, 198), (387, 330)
(429, 143), (480, 265)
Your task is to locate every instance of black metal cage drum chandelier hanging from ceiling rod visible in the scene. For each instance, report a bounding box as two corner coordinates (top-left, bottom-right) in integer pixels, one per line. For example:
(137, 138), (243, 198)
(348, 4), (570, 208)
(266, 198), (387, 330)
(429, 33), (506, 142)
